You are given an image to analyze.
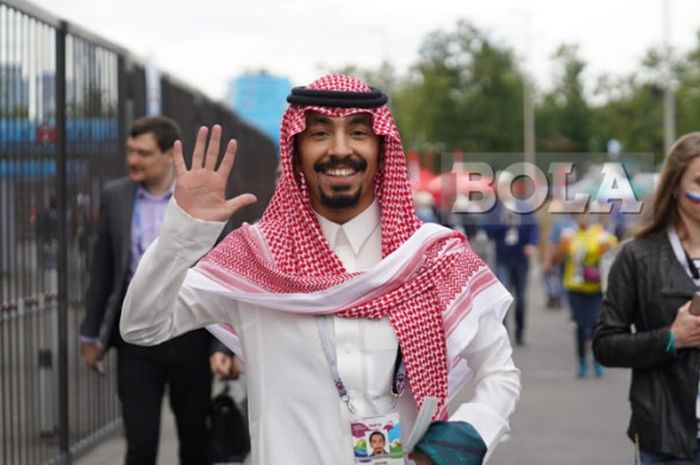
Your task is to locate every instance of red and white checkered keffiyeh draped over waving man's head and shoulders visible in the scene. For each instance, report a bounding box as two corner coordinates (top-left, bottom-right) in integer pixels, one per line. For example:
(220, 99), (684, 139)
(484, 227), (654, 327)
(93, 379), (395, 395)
(191, 74), (509, 419)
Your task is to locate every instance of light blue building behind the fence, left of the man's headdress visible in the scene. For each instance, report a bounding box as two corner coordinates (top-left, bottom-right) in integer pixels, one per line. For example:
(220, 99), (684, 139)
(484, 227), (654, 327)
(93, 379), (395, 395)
(226, 71), (291, 149)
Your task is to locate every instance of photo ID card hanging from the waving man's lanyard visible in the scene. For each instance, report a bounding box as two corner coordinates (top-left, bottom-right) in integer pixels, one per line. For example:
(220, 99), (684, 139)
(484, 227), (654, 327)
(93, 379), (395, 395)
(350, 413), (405, 465)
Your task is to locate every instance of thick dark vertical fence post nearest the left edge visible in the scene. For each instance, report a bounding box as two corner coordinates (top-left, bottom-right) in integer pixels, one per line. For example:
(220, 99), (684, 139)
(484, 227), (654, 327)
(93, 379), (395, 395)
(56, 21), (72, 465)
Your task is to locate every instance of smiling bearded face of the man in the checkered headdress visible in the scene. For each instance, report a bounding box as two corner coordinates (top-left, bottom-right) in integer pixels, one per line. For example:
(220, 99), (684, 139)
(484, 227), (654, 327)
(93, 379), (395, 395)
(296, 112), (381, 224)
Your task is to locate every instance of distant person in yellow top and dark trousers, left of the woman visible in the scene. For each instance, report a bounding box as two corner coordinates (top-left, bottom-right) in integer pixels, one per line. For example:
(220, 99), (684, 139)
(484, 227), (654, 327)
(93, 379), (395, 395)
(559, 211), (617, 378)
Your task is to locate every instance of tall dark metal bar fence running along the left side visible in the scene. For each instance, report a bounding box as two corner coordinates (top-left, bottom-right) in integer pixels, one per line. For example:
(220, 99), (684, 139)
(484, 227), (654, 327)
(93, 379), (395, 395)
(0, 0), (277, 465)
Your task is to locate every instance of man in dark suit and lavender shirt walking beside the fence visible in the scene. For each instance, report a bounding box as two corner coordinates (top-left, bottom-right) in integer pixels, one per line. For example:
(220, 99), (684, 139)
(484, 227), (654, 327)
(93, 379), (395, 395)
(81, 117), (211, 465)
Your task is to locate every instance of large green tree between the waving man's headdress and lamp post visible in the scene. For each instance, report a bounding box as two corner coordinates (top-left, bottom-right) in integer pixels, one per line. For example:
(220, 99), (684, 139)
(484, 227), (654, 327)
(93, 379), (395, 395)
(394, 21), (523, 151)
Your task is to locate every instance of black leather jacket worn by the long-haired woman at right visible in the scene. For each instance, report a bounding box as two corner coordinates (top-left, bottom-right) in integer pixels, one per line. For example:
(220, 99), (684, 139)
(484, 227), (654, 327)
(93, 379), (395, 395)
(593, 233), (700, 459)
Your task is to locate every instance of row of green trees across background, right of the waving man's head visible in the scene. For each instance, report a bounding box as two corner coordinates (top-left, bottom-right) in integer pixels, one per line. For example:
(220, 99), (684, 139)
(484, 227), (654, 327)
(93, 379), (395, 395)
(334, 21), (700, 163)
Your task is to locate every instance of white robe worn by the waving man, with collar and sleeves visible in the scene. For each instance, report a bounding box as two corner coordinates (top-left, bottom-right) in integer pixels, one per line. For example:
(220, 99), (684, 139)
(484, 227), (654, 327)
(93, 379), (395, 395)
(121, 201), (520, 465)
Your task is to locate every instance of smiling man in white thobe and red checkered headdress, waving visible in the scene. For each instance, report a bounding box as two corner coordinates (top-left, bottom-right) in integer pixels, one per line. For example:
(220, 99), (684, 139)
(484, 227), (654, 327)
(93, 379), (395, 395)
(121, 75), (520, 465)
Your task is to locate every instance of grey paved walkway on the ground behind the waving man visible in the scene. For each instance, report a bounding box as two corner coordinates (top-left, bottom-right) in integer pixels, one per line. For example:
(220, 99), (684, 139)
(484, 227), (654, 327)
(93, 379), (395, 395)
(76, 262), (633, 465)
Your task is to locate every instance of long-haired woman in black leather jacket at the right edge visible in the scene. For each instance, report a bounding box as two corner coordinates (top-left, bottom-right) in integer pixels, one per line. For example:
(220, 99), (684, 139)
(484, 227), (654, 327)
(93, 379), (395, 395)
(593, 132), (700, 465)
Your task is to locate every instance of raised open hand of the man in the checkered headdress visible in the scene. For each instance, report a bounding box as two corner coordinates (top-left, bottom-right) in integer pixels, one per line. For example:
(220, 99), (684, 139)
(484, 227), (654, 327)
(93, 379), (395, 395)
(173, 124), (256, 221)
